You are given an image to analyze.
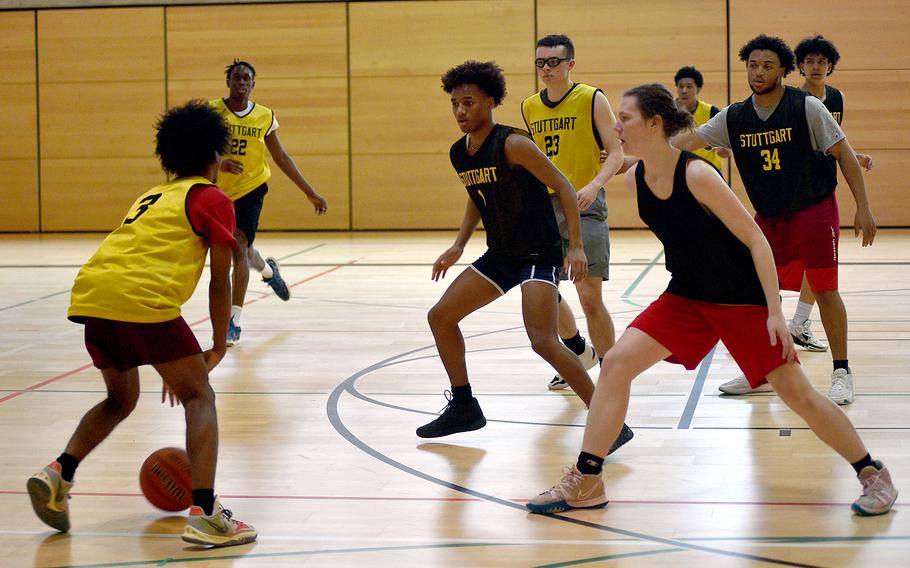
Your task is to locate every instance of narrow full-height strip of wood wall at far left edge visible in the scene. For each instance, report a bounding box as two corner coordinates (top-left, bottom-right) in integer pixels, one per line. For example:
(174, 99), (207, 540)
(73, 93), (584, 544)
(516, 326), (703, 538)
(0, 11), (39, 231)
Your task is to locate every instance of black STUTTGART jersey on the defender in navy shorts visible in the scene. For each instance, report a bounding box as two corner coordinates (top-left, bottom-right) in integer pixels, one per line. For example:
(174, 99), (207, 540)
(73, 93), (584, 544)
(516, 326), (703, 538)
(449, 124), (562, 266)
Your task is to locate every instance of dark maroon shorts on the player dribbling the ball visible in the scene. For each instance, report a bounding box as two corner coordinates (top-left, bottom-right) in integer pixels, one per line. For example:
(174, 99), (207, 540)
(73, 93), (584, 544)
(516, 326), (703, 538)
(80, 317), (202, 373)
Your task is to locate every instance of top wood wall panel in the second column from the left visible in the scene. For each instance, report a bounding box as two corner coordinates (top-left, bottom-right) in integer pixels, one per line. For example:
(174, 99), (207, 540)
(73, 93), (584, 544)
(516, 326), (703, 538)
(38, 7), (164, 81)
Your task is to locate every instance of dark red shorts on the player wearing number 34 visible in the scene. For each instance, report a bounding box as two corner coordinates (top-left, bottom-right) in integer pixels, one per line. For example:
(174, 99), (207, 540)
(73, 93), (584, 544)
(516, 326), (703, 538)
(755, 193), (840, 292)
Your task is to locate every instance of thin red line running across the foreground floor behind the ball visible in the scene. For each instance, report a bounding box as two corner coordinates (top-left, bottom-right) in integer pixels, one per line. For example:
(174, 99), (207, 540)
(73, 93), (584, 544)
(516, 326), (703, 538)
(0, 490), (876, 507)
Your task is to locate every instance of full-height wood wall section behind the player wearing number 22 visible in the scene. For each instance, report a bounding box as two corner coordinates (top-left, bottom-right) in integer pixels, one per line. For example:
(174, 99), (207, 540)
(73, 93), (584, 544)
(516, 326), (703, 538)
(167, 3), (350, 230)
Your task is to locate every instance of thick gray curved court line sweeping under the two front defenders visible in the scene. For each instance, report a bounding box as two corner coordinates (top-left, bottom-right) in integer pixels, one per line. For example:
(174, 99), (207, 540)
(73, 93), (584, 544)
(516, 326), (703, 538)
(326, 360), (820, 568)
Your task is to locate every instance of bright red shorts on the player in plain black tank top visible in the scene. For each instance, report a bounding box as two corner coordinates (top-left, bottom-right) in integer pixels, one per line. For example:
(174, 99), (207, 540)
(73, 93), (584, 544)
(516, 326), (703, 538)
(629, 292), (800, 388)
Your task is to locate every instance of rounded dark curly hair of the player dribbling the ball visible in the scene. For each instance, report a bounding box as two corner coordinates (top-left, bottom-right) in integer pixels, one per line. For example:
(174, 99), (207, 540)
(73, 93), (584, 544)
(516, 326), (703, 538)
(155, 100), (231, 177)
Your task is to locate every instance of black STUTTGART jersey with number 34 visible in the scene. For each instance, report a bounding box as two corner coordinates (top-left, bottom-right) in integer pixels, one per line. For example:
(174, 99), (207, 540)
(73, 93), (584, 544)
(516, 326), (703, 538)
(727, 87), (837, 217)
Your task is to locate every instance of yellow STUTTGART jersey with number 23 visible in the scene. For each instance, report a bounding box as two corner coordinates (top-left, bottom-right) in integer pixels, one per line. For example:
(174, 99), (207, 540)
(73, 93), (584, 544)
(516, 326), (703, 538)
(521, 83), (603, 193)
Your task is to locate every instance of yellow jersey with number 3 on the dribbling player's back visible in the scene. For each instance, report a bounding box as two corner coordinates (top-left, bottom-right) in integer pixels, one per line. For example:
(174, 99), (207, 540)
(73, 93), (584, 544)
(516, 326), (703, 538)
(67, 177), (212, 323)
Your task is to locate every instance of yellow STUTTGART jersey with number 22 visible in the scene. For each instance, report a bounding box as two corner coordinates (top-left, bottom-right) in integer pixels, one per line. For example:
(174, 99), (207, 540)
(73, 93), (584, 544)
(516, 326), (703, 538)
(209, 99), (275, 201)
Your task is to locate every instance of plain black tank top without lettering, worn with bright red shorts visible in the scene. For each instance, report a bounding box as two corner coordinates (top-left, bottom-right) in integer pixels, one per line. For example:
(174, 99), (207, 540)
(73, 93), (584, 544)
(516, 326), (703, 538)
(635, 152), (767, 306)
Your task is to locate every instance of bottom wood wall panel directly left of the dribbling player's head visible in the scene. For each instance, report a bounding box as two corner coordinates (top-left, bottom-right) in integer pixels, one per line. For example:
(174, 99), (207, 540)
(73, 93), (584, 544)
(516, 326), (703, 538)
(41, 158), (165, 231)
